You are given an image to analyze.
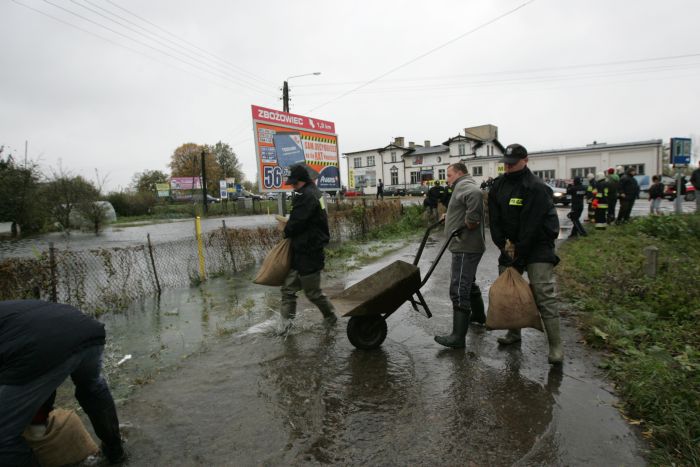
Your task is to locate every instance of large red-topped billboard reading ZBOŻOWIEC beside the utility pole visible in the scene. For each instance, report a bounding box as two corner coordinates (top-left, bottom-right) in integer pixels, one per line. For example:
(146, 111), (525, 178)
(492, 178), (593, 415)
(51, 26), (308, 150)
(252, 105), (340, 192)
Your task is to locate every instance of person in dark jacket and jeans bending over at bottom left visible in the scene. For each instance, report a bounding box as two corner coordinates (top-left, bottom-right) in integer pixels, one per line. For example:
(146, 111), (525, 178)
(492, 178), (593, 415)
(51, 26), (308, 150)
(0, 300), (125, 466)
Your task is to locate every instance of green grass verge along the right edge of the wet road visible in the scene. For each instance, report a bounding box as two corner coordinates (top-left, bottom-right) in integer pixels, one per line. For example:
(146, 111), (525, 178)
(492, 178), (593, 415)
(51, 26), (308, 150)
(557, 215), (700, 466)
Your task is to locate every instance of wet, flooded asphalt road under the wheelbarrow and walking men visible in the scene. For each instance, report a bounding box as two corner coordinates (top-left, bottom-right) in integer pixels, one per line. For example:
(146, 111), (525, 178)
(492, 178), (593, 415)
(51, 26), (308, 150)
(110, 210), (645, 466)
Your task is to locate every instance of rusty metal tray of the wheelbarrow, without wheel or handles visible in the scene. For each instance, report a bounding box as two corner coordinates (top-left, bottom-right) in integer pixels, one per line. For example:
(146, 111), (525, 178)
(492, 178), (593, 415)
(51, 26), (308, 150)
(331, 261), (421, 316)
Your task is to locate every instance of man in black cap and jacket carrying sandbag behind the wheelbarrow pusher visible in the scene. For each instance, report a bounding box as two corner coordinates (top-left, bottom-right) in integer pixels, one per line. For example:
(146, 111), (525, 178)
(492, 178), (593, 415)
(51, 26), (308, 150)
(489, 144), (564, 364)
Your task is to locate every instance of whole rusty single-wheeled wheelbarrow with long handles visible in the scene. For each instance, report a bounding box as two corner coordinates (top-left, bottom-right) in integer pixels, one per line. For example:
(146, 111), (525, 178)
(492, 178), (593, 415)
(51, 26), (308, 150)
(331, 220), (461, 350)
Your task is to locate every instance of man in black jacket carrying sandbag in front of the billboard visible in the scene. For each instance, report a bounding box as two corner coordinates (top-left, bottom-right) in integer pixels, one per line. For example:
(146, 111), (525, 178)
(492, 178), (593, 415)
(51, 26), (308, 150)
(280, 164), (337, 331)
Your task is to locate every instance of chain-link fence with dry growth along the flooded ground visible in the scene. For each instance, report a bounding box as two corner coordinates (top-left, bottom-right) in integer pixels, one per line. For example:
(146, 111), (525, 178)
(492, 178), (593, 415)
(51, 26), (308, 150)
(0, 200), (402, 315)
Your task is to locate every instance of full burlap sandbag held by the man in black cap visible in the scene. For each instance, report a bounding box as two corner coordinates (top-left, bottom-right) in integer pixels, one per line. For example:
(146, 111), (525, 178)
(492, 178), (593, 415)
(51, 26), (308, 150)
(486, 268), (542, 331)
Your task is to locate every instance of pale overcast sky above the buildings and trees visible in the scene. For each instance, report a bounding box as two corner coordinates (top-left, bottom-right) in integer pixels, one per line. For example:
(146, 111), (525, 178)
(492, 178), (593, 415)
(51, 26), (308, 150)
(0, 0), (700, 190)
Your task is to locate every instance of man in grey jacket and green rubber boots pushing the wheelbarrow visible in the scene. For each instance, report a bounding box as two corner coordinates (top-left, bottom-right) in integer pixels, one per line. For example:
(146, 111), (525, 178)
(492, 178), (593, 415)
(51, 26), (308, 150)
(435, 162), (486, 348)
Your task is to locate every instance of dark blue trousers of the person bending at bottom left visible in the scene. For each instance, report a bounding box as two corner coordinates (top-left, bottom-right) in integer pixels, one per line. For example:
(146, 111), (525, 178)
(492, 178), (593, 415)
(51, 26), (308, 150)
(0, 346), (114, 466)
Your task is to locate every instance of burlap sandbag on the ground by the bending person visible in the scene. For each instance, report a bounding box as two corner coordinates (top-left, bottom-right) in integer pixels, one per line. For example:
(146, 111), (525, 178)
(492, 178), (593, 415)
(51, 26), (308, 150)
(23, 409), (99, 467)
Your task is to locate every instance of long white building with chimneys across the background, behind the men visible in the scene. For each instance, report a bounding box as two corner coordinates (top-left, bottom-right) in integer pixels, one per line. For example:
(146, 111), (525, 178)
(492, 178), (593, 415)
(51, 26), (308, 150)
(343, 125), (664, 194)
